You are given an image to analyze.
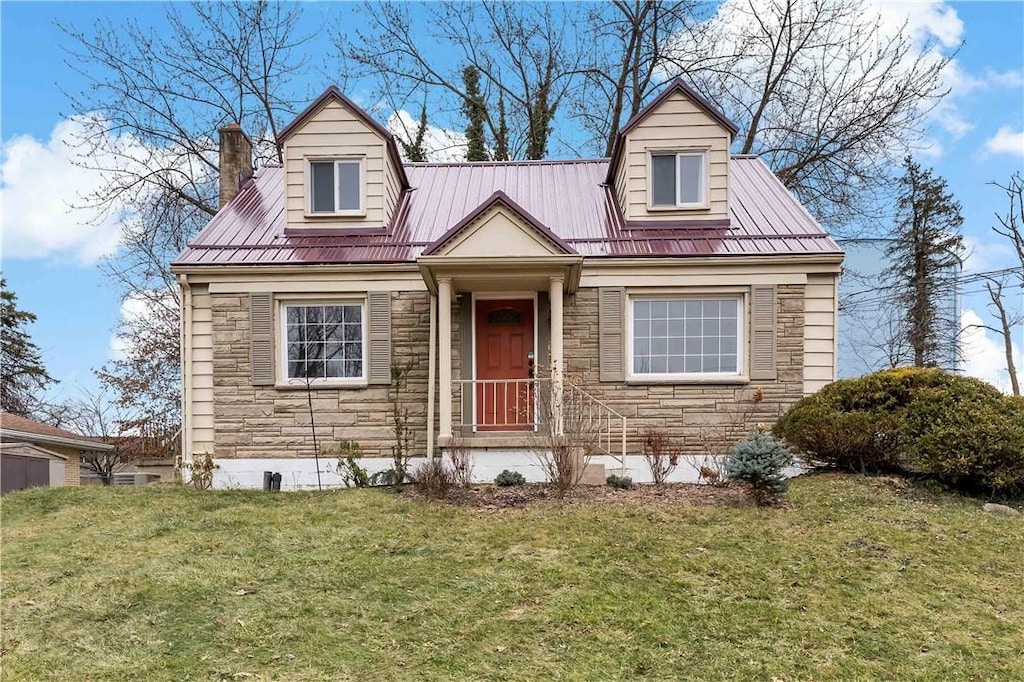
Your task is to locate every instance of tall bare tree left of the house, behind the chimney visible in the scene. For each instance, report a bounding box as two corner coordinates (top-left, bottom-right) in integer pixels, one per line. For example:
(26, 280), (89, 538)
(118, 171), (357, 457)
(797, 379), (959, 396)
(63, 1), (306, 416)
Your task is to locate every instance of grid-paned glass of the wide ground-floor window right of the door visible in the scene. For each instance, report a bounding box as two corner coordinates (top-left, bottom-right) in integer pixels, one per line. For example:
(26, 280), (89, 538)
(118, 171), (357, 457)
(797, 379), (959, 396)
(631, 297), (742, 377)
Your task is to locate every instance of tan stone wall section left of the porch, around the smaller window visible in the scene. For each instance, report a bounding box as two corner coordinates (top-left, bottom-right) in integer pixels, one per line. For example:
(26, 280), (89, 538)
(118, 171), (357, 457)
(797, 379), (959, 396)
(211, 292), (430, 459)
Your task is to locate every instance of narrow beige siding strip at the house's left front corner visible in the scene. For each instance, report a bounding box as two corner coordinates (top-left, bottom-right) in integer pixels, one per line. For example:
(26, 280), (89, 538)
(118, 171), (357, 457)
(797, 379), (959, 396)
(186, 287), (214, 454)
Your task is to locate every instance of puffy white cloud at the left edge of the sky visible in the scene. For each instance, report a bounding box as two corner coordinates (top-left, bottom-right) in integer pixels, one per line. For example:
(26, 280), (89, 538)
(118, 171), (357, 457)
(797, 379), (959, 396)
(0, 118), (134, 264)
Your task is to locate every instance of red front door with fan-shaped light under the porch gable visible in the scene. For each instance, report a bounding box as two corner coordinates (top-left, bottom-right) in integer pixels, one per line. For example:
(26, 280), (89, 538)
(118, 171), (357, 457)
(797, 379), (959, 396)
(476, 299), (534, 431)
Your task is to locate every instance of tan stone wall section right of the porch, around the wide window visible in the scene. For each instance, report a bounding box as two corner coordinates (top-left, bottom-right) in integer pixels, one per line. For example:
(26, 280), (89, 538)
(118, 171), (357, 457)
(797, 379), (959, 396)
(564, 285), (804, 455)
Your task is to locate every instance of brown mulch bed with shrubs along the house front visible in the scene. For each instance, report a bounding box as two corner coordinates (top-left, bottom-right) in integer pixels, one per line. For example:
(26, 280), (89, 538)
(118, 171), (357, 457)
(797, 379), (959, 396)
(401, 483), (750, 511)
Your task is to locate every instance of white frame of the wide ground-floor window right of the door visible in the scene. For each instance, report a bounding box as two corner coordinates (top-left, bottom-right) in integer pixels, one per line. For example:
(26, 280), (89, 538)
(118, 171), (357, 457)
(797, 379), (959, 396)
(626, 290), (750, 384)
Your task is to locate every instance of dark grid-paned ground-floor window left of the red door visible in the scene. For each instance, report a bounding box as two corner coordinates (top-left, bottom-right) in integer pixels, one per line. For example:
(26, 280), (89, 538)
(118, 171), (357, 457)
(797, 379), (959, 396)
(284, 302), (366, 381)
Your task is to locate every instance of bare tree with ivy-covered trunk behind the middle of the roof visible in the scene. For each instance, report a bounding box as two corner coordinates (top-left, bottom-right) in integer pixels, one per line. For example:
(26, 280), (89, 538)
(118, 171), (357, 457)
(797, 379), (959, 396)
(337, 1), (579, 159)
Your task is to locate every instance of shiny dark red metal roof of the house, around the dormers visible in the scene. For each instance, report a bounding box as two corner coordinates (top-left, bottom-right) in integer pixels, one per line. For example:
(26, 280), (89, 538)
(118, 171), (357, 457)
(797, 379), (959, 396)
(174, 157), (842, 266)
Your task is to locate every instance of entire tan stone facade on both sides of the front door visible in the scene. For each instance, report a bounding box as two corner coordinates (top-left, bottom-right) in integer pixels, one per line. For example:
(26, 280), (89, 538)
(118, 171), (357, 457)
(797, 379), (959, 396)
(211, 286), (804, 459)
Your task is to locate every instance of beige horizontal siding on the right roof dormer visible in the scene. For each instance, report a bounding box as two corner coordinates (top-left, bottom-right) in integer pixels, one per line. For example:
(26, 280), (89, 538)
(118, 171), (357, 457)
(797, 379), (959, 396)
(615, 92), (729, 220)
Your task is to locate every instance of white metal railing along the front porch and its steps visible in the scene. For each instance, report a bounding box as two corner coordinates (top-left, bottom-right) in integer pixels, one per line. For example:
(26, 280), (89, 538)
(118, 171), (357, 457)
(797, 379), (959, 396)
(452, 377), (627, 473)
